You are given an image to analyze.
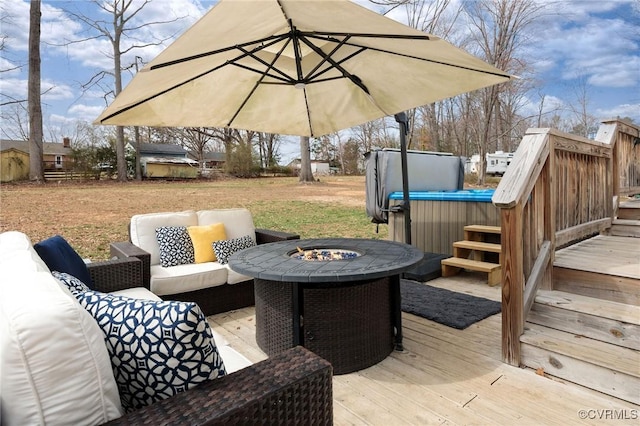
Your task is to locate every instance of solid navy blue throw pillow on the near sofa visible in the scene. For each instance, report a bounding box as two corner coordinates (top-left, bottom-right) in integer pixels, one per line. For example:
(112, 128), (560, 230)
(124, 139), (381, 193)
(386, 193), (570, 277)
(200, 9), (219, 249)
(33, 235), (93, 288)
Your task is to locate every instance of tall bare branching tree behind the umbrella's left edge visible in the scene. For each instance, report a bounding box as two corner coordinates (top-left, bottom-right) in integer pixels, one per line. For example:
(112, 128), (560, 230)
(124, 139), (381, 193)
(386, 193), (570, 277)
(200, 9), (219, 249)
(67, 0), (189, 182)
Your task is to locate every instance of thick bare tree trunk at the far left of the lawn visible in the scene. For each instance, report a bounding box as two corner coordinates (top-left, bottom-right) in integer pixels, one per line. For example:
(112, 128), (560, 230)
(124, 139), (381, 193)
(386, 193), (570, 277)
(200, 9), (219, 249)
(28, 0), (44, 183)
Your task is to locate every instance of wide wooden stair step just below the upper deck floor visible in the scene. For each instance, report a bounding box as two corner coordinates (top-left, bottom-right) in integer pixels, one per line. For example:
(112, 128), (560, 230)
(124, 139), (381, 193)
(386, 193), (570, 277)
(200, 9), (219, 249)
(527, 290), (640, 350)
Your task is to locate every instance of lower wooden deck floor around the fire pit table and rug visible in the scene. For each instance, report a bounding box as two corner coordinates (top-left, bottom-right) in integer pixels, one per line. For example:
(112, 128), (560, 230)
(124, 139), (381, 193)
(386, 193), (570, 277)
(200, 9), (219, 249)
(209, 273), (640, 425)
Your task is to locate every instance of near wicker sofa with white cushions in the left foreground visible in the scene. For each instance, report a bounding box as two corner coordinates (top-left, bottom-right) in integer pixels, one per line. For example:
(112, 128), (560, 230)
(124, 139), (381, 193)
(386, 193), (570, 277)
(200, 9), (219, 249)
(0, 232), (333, 426)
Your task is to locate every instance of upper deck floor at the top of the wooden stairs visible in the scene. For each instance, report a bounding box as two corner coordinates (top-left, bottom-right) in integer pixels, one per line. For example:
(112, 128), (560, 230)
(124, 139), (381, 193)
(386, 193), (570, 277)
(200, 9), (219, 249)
(554, 235), (640, 279)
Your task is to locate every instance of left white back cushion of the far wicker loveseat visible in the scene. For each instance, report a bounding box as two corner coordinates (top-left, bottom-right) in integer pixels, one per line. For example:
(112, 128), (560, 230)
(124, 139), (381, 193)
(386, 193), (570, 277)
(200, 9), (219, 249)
(129, 210), (198, 265)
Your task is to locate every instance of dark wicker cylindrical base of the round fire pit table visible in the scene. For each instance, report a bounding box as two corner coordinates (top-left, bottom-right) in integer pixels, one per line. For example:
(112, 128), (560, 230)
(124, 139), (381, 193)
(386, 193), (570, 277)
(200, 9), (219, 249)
(254, 277), (396, 374)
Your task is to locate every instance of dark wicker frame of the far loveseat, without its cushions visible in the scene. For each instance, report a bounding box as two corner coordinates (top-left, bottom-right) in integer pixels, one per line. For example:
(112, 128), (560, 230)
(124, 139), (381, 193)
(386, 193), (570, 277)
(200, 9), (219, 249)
(110, 229), (300, 315)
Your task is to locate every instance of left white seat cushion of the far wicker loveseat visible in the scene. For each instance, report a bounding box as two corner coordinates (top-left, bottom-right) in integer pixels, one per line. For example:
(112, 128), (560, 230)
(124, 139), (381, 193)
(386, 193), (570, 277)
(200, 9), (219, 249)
(150, 262), (228, 296)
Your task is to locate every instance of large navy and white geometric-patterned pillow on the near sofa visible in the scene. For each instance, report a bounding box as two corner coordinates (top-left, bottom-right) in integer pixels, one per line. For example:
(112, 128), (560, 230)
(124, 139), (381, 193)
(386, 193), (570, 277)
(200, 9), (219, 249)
(61, 277), (226, 412)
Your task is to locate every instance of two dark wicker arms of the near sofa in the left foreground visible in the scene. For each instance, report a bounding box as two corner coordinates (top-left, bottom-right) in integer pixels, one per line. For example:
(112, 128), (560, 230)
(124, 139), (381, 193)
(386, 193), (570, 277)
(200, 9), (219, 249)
(87, 257), (333, 425)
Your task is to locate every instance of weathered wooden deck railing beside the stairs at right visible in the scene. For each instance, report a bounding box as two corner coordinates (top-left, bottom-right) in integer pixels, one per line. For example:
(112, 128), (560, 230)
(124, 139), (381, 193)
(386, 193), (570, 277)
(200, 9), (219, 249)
(493, 120), (640, 365)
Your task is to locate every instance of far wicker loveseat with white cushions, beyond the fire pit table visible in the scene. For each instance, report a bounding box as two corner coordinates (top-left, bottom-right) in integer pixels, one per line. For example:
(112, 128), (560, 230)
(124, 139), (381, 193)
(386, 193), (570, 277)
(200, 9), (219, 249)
(110, 208), (300, 315)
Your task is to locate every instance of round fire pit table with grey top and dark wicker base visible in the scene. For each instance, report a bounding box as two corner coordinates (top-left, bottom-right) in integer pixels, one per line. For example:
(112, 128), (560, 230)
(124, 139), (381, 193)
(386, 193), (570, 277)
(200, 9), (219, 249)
(229, 238), (424, 374)
